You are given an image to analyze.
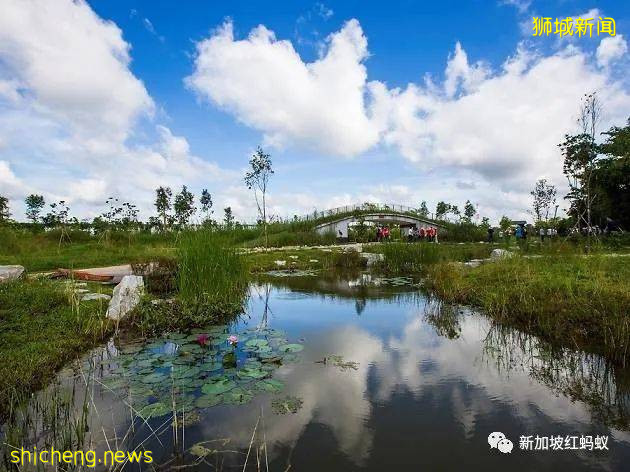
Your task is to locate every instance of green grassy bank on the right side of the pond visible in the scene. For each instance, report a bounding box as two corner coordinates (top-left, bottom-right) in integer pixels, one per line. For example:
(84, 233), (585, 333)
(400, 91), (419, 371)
(427, 255), (630, 363)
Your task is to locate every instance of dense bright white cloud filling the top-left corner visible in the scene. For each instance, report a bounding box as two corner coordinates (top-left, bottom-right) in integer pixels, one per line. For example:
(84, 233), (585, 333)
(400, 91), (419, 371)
(0, 0), (153, 141)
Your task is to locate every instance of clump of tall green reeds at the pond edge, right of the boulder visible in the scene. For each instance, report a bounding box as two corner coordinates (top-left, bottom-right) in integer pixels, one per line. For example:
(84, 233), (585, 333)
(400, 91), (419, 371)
(177, 230), (248, 308)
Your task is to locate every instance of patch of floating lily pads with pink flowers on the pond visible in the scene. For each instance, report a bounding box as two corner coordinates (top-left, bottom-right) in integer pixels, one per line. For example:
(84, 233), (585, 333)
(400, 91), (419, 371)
(87, 325), (303, 418)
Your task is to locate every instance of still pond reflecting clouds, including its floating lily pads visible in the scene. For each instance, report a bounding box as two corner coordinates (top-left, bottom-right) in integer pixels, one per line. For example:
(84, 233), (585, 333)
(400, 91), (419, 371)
(4, 274), (630, 471)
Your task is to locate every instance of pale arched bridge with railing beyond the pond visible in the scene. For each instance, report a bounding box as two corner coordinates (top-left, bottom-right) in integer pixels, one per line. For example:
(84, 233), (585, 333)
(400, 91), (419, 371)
(314, 210), (444, 238)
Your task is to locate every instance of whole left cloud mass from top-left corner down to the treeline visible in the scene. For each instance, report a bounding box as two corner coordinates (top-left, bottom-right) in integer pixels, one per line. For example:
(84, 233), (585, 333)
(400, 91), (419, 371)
(0, 0), (233, 217)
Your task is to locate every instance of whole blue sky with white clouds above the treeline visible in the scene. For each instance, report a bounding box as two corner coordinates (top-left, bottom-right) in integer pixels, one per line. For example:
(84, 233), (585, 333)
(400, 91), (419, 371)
(0, 0), (630, 220)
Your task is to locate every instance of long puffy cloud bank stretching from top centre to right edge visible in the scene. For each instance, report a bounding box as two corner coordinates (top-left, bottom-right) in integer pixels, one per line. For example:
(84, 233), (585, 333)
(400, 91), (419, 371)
(187, 17), (630, 212)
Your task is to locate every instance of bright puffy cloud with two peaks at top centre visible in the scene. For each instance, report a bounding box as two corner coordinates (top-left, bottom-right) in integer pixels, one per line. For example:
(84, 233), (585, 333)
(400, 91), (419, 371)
(186, 20), (378, 156)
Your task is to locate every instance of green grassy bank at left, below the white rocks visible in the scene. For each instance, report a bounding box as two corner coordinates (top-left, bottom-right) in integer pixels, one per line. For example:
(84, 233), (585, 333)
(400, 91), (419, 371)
(0, 281), (111, 416)
